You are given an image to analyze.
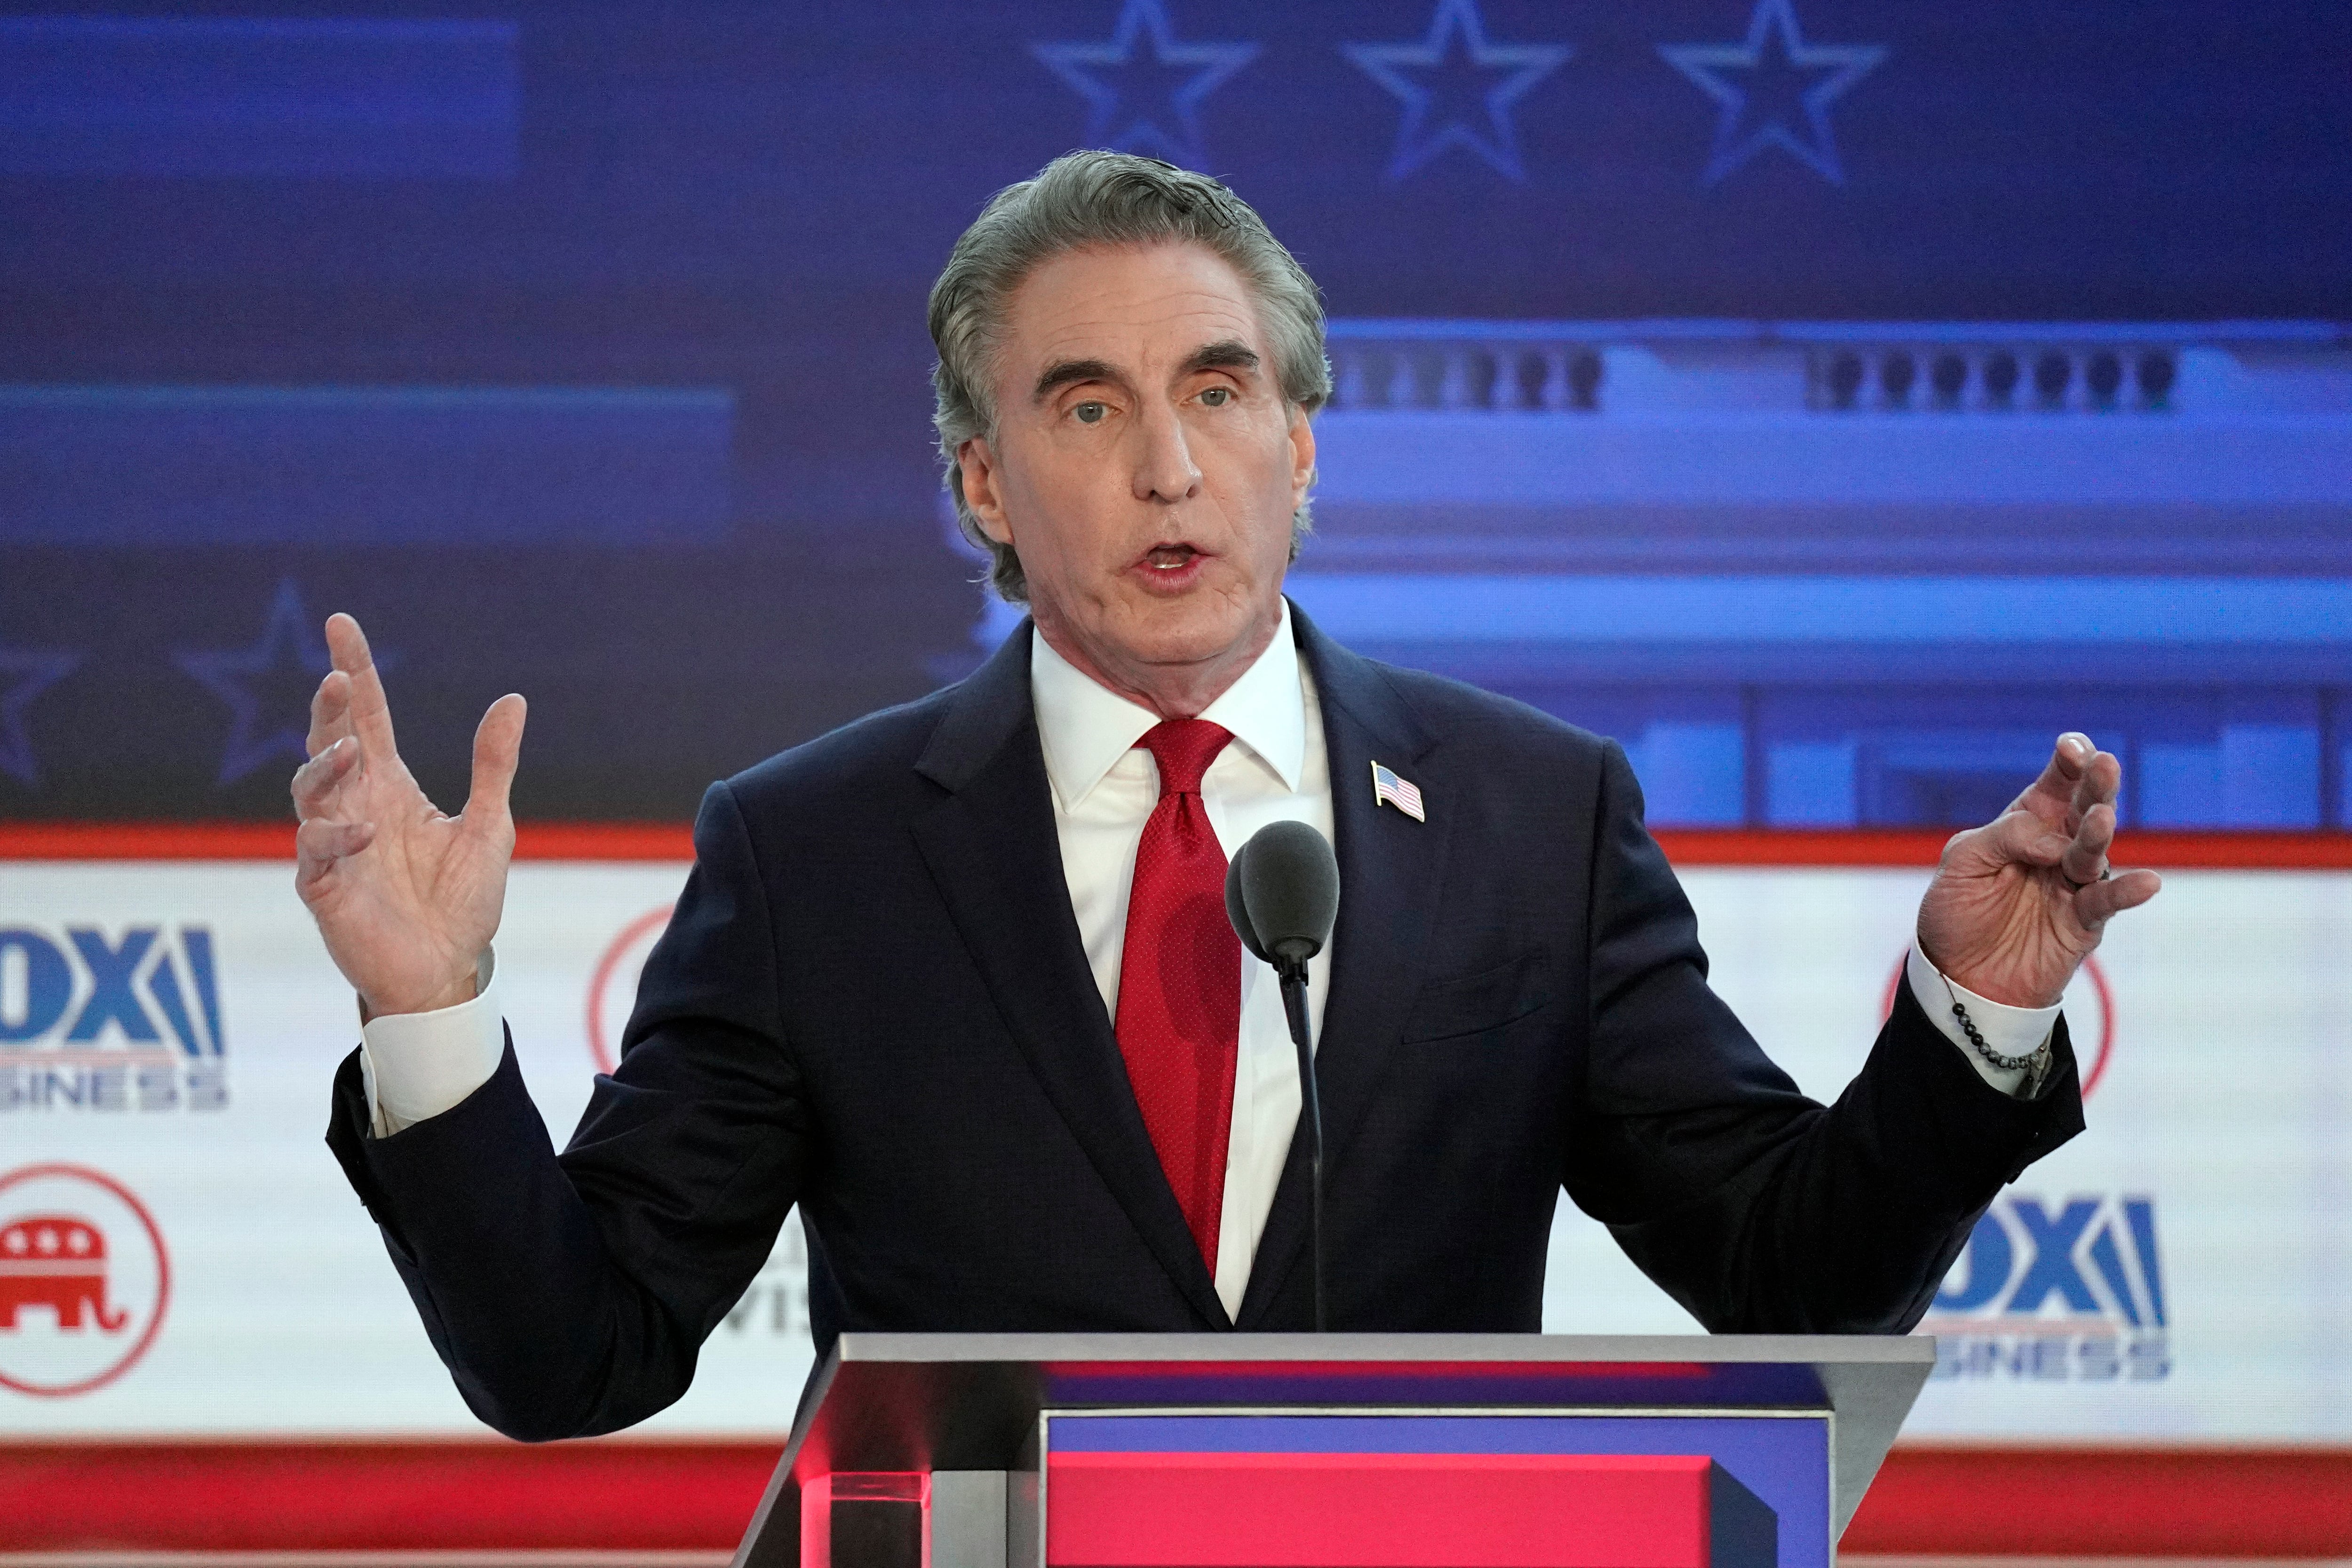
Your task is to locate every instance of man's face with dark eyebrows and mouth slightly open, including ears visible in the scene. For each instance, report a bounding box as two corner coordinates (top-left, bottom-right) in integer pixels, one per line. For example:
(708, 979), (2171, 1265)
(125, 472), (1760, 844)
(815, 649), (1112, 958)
(957, 245), (1315, 712)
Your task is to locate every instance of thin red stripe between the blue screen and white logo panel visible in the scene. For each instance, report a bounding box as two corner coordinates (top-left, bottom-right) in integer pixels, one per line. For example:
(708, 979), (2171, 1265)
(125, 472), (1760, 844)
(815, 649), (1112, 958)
(0, 823), (2352, 870)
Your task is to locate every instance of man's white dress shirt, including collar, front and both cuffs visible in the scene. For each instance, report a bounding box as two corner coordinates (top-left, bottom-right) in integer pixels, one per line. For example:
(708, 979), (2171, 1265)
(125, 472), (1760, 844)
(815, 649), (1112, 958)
(360, 604), (2058, 1316)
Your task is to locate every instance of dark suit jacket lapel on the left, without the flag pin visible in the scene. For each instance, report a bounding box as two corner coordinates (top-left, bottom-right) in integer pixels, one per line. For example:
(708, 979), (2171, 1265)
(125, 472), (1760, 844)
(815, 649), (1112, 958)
(915, 625), (1232, 1328)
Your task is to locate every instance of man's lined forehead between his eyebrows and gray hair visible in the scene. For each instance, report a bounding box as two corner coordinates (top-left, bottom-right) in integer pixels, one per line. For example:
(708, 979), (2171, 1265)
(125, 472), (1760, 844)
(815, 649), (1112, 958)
(997, 242), (1265, 392)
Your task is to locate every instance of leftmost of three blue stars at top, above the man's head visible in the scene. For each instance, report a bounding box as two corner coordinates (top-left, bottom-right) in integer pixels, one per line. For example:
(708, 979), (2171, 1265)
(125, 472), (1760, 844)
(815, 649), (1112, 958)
(1030, 0), (1258, 169)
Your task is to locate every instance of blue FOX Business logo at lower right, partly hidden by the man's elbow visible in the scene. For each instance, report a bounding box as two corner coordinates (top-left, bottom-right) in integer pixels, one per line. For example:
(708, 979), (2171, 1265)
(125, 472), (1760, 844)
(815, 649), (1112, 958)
(1919, 1196), (2173, 1382)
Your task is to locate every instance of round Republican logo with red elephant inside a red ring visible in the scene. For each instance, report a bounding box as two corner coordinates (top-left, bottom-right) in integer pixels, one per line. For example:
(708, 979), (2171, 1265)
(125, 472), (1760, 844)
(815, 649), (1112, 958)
(0, 1164), (172, 1399)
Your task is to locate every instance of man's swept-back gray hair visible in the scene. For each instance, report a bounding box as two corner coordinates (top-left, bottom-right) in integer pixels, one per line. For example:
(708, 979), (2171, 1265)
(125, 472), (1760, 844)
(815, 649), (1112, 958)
(931, 153), (1331, 604)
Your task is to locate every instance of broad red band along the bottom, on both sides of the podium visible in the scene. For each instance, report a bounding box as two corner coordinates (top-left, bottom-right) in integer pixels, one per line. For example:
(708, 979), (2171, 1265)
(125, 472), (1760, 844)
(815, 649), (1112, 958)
(0, 1439), (2352, 1559)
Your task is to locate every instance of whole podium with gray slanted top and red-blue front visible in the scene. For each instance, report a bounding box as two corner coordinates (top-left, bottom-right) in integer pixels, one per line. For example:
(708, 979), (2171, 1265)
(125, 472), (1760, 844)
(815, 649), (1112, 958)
(734, 1333), (1936, 1568)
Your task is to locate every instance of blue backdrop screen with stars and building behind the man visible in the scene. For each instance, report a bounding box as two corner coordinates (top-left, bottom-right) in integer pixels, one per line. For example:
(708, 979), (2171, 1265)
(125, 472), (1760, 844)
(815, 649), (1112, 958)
(0, 0), (2352, 828)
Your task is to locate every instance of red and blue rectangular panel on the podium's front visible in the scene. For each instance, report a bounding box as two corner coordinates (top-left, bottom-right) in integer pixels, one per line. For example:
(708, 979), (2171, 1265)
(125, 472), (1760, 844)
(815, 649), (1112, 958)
(1042, 1410), (1830, 1568)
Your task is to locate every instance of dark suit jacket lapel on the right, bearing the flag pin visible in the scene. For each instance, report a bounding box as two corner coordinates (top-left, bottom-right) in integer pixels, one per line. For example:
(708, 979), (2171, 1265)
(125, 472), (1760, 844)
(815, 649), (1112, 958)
(1240, 604), (1451, 1330)
